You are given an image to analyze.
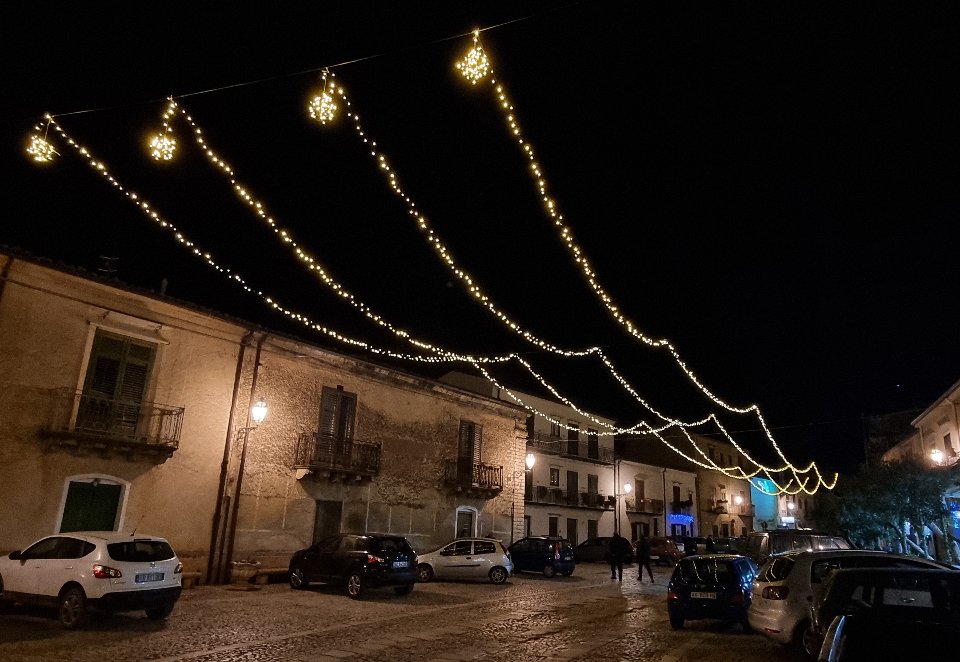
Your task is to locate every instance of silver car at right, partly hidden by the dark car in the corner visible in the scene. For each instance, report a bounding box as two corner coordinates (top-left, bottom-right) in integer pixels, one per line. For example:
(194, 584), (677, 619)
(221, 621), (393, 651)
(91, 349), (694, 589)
(747, 549), (944, 659)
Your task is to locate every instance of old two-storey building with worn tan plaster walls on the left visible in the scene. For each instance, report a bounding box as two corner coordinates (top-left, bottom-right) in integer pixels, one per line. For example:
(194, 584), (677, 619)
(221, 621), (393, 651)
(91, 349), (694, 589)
(0, 252), (526, 581)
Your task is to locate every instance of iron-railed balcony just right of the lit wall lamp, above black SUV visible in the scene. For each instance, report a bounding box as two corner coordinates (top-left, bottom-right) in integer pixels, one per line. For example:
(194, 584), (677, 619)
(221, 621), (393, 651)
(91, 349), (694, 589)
(293, 432), (380, 482)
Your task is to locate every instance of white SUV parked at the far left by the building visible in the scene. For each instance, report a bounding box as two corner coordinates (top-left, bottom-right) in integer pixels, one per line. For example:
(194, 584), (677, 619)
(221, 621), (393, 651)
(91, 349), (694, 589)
(0, 531), (183, 629)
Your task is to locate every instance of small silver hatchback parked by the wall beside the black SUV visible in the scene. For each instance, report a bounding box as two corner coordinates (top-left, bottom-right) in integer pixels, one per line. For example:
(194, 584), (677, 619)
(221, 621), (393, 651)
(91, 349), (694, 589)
(417, 538), (513, 584)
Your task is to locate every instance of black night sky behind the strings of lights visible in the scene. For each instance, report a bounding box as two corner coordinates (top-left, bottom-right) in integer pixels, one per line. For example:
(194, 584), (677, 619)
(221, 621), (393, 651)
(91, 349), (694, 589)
(0, 0), (960, 478)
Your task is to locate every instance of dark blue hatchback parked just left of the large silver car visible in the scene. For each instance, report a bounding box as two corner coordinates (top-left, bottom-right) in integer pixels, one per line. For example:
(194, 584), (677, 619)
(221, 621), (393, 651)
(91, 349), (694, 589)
(667, 554), (757, 632)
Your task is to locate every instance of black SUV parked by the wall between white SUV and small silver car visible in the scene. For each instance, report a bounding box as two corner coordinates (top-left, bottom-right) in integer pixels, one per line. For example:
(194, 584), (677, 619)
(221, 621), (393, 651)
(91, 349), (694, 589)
(290, 533), (417, 599)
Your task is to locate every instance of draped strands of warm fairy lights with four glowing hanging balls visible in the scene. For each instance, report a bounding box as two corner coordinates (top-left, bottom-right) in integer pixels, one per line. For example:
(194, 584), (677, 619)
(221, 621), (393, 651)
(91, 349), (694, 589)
(18, 26), (836, 494)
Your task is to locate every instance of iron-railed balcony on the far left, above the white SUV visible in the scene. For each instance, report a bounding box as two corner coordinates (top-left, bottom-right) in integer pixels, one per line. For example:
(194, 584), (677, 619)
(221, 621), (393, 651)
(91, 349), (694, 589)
(40, 389), (184, 461)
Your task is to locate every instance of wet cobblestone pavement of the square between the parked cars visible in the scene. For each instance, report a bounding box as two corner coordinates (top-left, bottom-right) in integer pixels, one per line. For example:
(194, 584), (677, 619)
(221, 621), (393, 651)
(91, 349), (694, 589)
(0, 564), (804, 662)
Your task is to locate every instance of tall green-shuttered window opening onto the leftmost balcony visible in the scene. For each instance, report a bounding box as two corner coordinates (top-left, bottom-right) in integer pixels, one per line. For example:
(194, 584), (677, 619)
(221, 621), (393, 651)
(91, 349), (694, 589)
(77, 329), (157, 437)
